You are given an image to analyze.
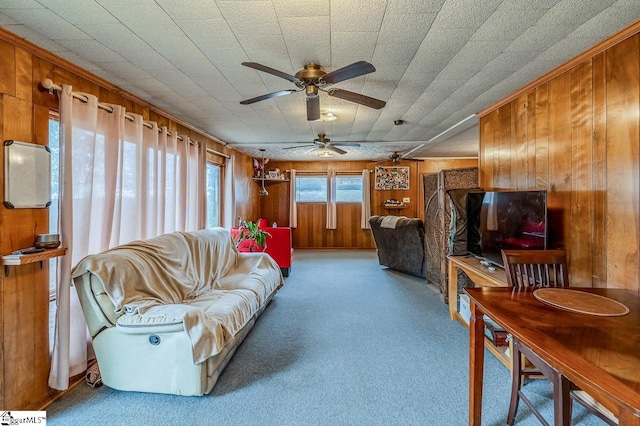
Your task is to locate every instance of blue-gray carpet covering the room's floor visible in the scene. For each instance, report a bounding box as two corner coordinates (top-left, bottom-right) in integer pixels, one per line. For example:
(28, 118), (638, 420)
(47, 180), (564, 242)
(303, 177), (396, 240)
(47, 250), (602, 426)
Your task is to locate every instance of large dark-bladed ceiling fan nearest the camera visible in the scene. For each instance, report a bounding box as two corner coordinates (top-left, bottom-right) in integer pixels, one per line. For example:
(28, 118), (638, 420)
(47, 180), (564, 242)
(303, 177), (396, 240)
(240, 61), (386, 121)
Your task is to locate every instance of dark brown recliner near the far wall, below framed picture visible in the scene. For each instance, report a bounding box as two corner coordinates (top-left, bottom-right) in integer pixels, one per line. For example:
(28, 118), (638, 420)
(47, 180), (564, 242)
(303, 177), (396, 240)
(369, 216), (426, 278)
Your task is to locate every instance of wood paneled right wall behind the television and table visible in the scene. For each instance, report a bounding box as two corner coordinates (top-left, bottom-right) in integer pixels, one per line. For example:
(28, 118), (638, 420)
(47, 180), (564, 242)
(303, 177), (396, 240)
(480, 30), (640, 291)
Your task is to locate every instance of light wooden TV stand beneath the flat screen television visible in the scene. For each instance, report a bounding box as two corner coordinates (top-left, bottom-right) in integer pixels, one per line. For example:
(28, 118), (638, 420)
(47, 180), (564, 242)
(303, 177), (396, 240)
(447, 256), (511, 370)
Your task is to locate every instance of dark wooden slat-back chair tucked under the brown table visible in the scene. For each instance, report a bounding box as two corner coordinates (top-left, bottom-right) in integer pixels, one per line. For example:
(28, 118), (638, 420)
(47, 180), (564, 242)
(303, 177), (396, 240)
(502, 250), (617, 425)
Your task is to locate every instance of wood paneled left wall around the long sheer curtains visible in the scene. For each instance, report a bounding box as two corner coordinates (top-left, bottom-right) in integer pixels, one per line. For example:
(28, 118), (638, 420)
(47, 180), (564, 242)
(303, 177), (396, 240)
(0, 29), (258, 410)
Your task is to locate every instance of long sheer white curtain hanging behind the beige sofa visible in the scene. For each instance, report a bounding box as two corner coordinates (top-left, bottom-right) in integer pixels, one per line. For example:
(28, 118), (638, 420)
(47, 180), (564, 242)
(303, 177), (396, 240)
(49, 85), (204, 390)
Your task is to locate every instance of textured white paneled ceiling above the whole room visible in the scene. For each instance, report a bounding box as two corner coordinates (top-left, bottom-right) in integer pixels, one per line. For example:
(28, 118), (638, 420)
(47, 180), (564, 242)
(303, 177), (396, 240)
(0, 0), (640, 160)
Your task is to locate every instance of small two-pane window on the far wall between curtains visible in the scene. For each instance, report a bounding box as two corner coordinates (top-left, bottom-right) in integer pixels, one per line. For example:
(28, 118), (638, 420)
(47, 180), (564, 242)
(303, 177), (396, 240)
(296, 176), (362, 203)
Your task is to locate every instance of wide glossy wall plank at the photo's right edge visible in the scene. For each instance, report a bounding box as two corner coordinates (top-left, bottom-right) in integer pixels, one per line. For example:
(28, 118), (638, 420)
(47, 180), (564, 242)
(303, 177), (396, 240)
(605, 35), (640, 291)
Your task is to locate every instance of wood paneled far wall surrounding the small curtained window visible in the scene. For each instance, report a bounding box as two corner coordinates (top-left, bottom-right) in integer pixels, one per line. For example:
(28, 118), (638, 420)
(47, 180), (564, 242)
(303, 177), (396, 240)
(262, 159), (478, 249)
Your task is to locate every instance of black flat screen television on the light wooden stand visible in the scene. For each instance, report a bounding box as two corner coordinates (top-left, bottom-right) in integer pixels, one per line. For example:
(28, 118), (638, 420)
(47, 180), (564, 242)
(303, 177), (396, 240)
(467, 190), (548, 267)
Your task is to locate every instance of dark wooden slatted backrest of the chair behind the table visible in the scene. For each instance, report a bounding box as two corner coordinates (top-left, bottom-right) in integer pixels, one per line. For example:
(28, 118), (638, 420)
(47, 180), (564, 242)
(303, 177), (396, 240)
(502, 250), (569, 287)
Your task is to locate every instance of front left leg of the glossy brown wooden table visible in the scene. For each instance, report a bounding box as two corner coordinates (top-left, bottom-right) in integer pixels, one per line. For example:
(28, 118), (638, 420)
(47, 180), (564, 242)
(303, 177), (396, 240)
(469, 299), (484, 426)
